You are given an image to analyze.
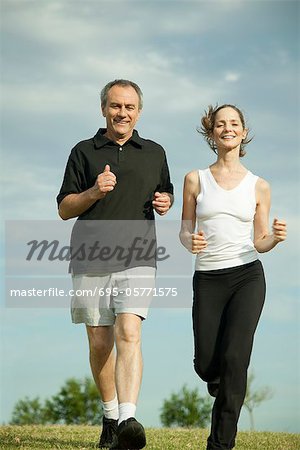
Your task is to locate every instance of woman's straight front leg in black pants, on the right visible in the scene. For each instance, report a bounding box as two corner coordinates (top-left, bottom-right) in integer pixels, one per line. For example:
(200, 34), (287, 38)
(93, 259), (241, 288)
(207, 261), (265, 450)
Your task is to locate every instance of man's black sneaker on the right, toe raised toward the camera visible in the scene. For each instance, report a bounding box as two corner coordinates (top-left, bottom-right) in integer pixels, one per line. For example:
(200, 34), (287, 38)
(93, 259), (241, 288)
(109, 417), (146, 450)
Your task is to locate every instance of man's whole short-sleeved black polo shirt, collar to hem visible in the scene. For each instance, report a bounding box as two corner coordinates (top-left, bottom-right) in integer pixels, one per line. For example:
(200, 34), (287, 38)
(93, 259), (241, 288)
(57, 129), (173, 274)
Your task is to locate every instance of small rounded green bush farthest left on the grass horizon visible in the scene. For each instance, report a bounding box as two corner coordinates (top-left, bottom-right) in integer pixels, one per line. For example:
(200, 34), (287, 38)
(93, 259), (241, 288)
(11, 397), (45, 425)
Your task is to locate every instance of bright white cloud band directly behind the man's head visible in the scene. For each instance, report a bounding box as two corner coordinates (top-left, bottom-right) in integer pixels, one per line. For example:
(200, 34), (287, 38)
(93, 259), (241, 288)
(3, 50), (222, 114)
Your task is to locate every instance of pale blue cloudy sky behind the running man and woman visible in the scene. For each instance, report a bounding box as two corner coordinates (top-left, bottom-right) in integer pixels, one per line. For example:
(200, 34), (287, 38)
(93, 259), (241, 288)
(0, 0), (300, 432)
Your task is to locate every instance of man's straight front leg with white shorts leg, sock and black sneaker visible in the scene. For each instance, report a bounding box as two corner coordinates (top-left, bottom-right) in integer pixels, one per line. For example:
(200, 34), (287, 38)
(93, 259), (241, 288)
(111, 267), (155, 450)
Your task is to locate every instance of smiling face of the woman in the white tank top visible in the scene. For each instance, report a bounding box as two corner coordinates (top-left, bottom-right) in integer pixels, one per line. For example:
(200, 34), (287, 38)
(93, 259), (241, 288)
(212, 107), (247, 150)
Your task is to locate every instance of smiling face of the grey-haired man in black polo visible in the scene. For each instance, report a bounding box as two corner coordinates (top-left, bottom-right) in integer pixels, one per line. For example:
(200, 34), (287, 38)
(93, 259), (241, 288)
(102, 85), (140, 141)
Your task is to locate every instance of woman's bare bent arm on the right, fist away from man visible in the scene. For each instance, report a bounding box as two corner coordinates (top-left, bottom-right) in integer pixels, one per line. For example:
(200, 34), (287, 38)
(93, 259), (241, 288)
(254, 178), (286, 253)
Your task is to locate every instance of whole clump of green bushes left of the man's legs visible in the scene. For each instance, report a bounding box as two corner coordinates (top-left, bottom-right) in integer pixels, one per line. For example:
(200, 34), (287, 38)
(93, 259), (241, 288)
(12, 378), (102, 425)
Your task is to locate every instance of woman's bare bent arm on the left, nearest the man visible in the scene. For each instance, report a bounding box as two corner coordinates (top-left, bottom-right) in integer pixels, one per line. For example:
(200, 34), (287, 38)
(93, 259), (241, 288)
(179, 171), (207, 253)
